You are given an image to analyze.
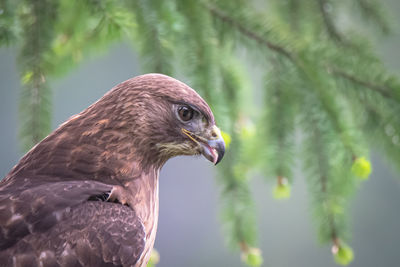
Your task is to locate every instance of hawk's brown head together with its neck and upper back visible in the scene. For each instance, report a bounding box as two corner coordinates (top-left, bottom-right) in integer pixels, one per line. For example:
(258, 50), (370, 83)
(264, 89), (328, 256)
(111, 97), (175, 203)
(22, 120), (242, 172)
(9, 74), (225, 181)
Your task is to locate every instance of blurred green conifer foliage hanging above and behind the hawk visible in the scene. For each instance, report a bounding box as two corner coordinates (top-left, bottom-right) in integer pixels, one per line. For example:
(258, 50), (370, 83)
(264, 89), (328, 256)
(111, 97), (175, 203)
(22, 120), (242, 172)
(0, 0), (400, 266)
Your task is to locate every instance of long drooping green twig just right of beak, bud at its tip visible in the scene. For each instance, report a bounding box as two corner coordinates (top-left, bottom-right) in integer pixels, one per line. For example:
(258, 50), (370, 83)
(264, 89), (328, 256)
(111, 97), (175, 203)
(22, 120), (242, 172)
(217, 49), (262, 266)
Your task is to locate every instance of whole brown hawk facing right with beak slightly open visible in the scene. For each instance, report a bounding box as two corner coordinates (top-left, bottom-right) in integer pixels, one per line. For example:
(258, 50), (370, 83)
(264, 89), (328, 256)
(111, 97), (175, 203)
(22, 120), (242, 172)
(0, 74), (225, 266)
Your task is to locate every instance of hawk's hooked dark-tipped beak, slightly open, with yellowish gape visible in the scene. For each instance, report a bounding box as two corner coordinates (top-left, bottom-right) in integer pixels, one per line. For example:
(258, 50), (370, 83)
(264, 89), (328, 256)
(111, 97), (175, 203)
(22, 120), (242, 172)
(182, 126), (225, 165)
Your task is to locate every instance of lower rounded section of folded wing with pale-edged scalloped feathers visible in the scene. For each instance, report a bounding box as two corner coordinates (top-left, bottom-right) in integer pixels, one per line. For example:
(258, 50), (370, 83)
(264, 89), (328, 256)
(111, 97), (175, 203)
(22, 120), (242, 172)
(0, 201), (145, 266)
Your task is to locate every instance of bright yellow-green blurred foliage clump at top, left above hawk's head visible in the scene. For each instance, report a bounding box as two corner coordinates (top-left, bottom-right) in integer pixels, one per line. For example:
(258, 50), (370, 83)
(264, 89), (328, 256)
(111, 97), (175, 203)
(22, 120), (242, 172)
(48, 0), (135, 76)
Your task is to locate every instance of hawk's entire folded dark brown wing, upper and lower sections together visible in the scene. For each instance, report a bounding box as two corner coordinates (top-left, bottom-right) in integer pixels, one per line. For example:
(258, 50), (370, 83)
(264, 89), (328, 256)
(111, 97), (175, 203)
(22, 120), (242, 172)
(0, 179), (145, 266)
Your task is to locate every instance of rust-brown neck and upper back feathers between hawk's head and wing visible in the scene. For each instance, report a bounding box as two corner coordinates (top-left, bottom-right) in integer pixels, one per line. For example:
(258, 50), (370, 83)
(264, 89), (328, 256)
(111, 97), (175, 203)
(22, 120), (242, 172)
(7, 115), (164, 184)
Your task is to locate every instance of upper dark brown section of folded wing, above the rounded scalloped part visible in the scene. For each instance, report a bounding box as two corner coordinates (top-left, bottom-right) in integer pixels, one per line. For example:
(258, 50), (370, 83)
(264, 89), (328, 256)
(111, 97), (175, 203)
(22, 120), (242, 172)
(0, 179), (112, 250)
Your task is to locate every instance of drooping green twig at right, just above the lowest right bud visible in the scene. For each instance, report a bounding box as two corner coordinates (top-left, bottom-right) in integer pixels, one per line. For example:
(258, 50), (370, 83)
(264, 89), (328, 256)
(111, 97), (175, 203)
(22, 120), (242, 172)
(303, 113), (352, 246)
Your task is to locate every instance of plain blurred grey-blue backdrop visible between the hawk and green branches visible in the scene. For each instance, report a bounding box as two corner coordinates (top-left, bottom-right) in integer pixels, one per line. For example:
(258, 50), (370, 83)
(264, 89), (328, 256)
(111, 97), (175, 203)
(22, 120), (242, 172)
(0, 0), (400, 267)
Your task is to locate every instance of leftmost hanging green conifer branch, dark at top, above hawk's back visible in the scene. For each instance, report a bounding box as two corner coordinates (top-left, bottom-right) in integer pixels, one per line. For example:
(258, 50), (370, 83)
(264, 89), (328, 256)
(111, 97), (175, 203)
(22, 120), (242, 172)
(19, 0), (57, 150)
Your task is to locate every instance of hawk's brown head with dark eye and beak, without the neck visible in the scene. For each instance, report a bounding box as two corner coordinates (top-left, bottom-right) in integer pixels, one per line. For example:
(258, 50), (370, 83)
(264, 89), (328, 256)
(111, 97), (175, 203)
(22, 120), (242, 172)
(92, 74), (225, 170)
